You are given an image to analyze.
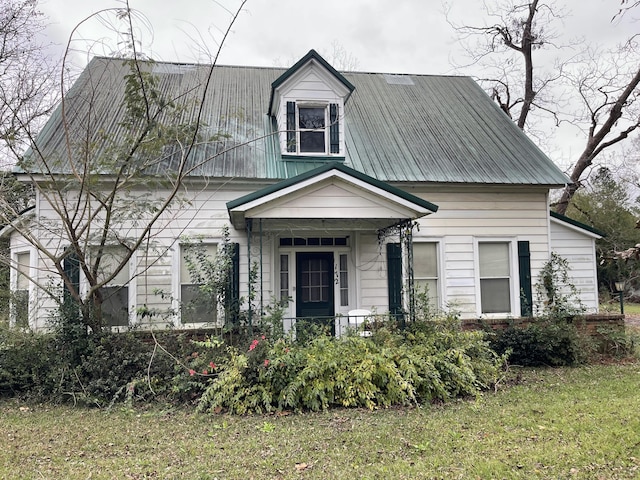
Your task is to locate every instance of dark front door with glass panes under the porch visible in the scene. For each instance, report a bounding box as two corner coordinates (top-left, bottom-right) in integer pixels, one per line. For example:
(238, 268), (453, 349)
(296, 252), (335, 335)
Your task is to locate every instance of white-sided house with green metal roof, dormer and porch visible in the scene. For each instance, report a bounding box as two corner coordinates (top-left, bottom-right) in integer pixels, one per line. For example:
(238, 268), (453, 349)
(2, 50), (598, 329)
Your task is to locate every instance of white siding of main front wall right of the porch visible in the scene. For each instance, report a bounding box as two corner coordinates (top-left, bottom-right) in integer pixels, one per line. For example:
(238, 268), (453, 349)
(412, 187), (549, 318)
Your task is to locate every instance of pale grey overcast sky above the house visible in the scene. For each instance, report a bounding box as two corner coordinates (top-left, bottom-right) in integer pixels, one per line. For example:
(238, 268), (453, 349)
(40, 0), (640, 170)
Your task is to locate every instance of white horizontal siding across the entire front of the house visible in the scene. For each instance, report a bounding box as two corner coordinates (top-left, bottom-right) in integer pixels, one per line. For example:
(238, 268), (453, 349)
(12, 178), (597, 326)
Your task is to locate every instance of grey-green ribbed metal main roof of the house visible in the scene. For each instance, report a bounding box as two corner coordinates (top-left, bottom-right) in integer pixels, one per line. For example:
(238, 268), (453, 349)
(25, 52), (569, 187)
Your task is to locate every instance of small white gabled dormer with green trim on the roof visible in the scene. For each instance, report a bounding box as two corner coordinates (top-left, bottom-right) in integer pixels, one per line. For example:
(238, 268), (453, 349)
(269, 50), (355, 160)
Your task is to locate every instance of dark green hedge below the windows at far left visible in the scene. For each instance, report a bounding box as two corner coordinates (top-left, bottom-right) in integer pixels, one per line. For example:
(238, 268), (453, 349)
(0, 325), (188, 407)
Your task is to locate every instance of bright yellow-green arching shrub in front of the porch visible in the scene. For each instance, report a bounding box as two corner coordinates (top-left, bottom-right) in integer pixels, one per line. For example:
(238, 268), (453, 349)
(198, 312), (504, 414)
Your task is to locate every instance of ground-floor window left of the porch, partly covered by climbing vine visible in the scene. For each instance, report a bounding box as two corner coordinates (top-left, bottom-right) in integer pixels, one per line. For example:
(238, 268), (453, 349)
(180, 243), (218, 323)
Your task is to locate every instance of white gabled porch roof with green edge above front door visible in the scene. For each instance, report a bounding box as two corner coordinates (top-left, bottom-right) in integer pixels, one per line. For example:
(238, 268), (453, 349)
(227, 163), (438, 229)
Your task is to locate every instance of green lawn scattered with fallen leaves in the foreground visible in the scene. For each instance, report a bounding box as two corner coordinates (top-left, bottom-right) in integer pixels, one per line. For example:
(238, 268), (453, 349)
(0, 363), (640, 480)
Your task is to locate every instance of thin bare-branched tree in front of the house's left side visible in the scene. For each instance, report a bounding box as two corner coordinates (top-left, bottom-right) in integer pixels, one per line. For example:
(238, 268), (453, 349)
(0, 0), (246, 332)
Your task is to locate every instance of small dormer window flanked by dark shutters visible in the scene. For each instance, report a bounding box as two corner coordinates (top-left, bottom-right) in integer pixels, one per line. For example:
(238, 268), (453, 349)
(286, 102), (340, 155)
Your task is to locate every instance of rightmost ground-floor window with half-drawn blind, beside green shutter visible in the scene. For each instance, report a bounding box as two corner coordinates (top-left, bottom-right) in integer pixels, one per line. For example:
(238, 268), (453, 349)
(478, 242), (511, 314)
